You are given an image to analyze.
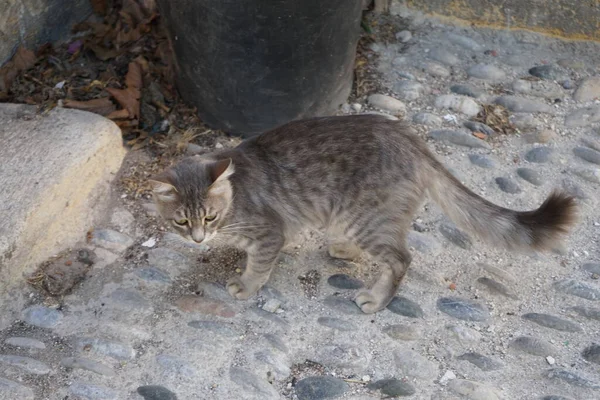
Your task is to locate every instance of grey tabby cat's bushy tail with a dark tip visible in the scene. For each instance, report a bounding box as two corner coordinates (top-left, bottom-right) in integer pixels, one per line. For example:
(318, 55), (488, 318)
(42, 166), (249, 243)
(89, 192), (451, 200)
(428, 160), (577, 251)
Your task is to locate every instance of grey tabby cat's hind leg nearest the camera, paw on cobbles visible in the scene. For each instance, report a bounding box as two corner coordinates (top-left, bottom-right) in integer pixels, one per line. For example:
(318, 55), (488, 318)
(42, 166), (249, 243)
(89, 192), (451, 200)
(354, 240), (412, 314)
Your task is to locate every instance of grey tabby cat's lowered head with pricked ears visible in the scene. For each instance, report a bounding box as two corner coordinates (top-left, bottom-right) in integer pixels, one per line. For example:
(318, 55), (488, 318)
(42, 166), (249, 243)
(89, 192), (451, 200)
(149, 157), (235, 243)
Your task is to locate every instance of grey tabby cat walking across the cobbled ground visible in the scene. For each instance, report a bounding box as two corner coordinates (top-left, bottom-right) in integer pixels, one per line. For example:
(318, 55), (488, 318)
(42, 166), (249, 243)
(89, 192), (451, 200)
(152, 115), (576, 313)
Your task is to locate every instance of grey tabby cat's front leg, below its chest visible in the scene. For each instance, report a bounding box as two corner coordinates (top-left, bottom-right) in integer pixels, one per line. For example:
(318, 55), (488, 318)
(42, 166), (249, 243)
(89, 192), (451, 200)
(227, 233), (284, 300)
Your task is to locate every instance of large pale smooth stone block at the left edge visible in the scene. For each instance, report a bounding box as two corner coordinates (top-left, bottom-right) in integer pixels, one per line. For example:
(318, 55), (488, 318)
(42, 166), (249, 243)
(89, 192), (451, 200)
(0, 103), (126, 326)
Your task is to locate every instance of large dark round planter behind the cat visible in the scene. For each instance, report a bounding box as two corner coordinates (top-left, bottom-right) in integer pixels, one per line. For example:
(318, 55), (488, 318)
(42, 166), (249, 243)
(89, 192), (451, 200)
(158, 0), (362, 136)
